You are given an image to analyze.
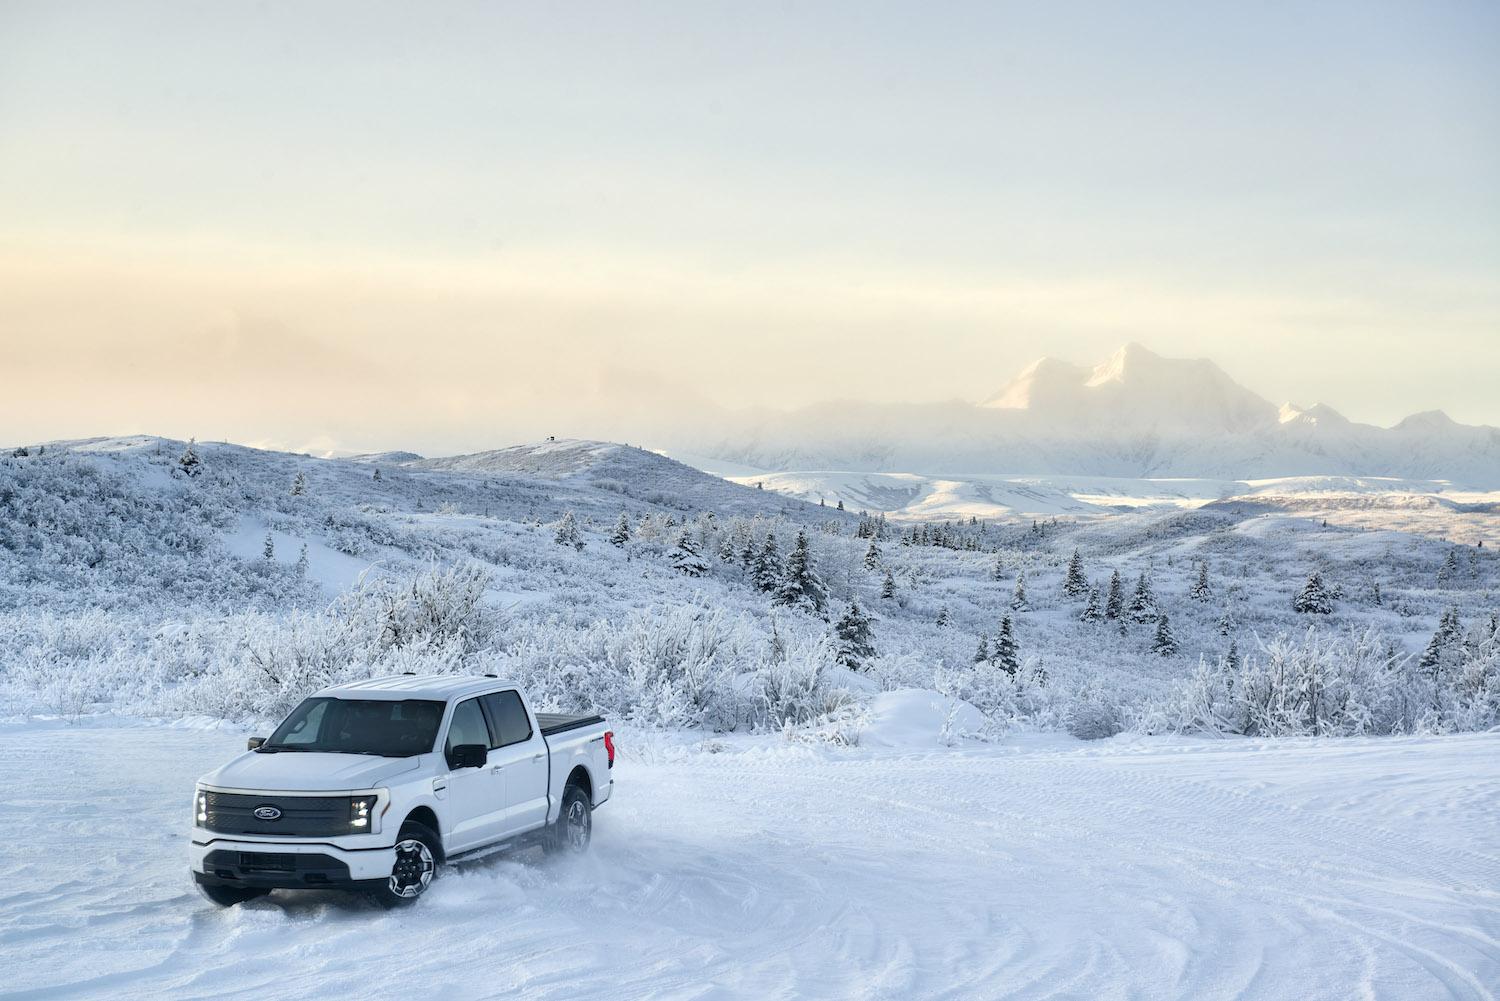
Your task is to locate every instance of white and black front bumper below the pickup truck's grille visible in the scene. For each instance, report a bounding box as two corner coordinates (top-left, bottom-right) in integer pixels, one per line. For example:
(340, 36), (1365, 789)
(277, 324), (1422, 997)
(191, 831), (396, 890)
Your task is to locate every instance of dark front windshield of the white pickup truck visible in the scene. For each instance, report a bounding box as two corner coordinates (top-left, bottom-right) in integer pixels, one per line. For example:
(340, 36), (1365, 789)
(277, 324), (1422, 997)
(261, 698), (443, 758)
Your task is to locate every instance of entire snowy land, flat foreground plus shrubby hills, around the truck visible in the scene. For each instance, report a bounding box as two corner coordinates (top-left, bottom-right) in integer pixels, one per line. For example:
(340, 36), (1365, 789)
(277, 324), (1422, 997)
(0, 437), (1500, 1001)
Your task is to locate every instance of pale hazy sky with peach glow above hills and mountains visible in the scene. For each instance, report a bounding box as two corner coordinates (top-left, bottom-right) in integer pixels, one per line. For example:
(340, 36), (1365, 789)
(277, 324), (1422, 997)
(0, 0), (1500, 452)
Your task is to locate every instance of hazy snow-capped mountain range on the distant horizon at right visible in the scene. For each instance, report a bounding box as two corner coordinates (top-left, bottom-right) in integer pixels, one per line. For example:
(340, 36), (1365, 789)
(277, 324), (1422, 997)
(666, 344), (1500, 489)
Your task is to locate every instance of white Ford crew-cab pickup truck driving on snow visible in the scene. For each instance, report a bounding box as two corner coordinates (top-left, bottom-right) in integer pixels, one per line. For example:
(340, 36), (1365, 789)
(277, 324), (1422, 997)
(192, 675), (615, 906)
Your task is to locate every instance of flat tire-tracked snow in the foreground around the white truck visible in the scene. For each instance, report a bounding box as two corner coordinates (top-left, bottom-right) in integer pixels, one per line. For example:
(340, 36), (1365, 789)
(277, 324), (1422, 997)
(0, 713), (1500, 1001)
